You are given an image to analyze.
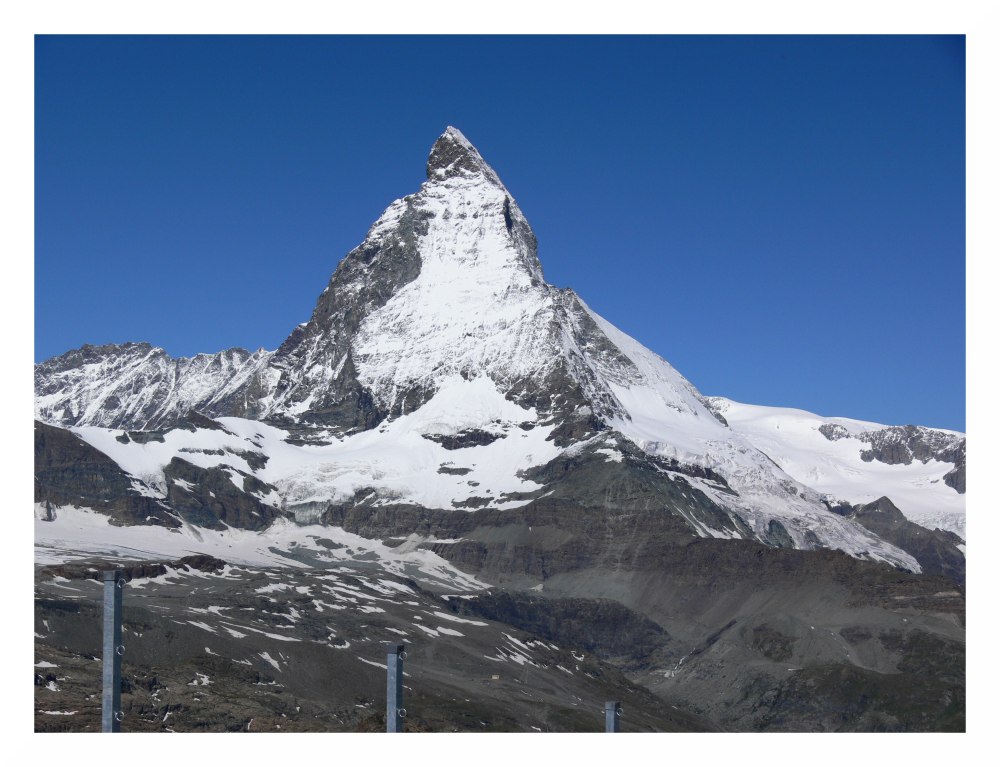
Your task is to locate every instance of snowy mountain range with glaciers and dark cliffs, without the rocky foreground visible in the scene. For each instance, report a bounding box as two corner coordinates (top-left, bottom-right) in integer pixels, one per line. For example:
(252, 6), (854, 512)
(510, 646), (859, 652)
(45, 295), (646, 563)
(35, 128), (965, 727)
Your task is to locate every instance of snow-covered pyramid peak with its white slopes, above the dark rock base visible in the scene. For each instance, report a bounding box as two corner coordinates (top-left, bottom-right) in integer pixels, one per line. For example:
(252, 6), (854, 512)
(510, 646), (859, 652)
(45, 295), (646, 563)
(36, 128), (948, 570)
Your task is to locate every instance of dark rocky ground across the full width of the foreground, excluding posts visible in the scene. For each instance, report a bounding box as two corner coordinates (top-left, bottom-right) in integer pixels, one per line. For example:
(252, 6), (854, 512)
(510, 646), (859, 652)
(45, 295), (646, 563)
(35, 548), (965, 732)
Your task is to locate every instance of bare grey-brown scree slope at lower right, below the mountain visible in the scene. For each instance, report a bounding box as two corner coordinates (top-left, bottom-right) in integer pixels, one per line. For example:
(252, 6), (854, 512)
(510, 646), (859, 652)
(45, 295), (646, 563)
(516, 539), (964, 732)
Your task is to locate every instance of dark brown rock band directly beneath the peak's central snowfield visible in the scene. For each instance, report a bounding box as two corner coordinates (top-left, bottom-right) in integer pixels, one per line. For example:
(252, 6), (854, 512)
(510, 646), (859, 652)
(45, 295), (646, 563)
(322, 444), (754, 582)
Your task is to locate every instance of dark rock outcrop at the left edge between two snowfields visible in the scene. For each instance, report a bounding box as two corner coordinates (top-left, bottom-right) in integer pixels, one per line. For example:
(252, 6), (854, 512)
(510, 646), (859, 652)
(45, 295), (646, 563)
(35, 421), (180, 527)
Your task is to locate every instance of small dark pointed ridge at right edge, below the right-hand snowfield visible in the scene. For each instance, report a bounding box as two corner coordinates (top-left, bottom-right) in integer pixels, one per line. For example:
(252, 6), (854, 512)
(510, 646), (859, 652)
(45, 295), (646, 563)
(851, 497), (965, 584)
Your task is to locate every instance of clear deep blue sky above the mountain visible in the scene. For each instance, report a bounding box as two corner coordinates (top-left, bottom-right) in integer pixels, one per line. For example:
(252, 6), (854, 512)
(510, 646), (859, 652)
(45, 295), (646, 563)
(35, 36), (965, 430)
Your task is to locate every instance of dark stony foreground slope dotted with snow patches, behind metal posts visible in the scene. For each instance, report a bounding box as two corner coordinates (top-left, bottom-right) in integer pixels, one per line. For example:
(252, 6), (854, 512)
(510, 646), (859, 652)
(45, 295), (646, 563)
(35, 557), (716, 732)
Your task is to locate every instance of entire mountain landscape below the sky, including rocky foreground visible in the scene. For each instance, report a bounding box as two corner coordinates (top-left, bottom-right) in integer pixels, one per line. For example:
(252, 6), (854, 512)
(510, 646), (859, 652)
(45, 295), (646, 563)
(35, 128), (965, 732)
